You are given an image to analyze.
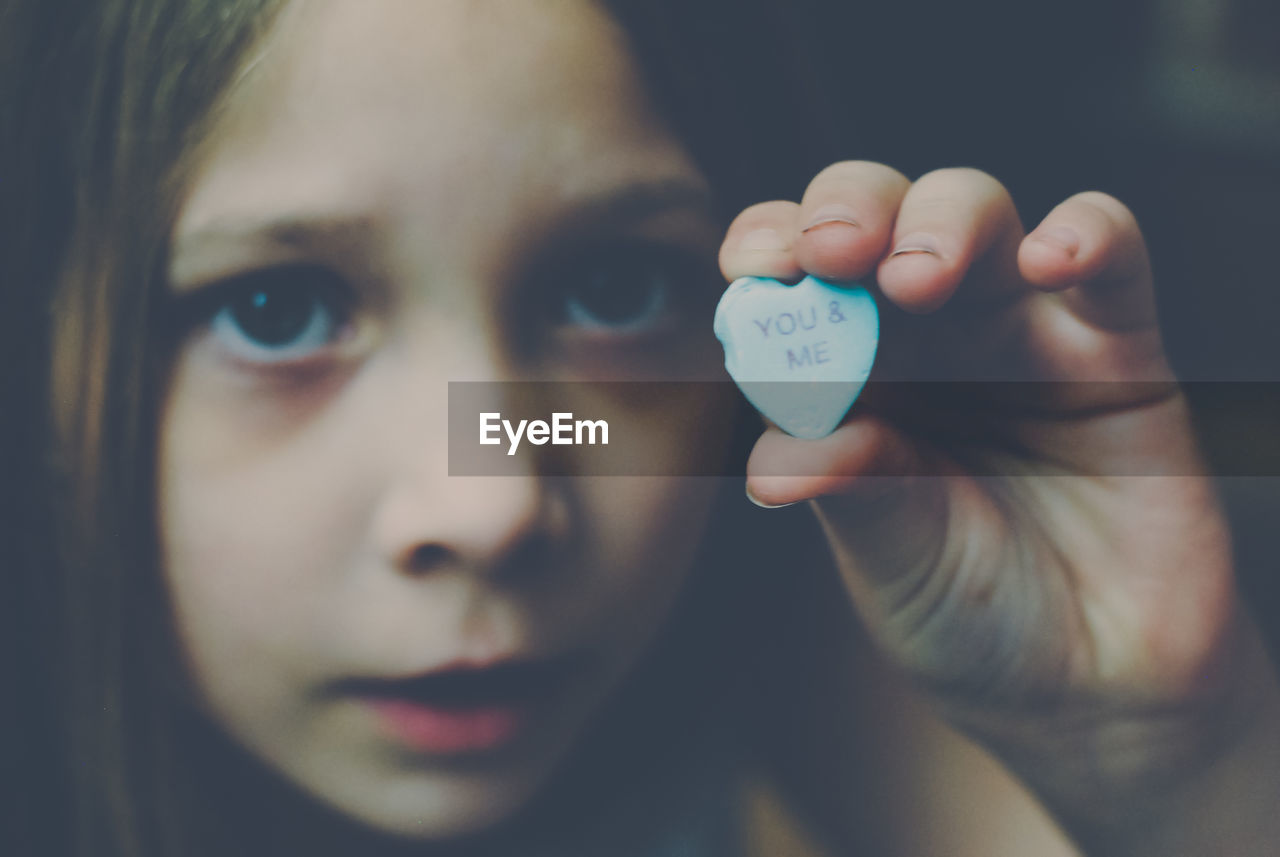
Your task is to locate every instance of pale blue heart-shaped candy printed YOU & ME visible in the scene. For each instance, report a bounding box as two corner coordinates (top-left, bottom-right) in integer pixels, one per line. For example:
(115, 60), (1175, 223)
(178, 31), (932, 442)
(716, 276), (879, 437)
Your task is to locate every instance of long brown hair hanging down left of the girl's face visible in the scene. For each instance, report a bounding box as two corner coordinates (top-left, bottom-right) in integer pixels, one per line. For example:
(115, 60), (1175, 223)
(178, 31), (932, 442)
(0, 0), (278, 857)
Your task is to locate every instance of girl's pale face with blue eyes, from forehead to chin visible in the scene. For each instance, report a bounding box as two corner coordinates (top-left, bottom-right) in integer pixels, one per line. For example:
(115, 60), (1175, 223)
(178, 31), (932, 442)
(159, 0), (728, 838)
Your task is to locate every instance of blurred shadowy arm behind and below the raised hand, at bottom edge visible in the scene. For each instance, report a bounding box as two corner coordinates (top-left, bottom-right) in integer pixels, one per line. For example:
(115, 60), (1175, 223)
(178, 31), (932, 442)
(748, 544), (1079, 857)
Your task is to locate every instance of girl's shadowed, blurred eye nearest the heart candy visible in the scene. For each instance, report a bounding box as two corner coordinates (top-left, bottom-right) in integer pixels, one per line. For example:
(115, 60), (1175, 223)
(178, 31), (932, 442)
(552, 247), (707, 335)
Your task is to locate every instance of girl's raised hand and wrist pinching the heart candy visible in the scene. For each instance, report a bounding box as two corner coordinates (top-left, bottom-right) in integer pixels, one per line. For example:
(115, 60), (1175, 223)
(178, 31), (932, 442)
(721, 162), (1280, 854)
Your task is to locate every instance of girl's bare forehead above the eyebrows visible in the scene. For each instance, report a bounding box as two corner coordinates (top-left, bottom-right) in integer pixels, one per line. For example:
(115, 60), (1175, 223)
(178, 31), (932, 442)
(182, 0), (691, 241)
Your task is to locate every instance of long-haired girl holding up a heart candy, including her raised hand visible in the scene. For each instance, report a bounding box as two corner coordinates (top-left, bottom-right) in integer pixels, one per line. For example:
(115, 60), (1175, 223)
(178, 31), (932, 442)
(4, 0), (1280, 857)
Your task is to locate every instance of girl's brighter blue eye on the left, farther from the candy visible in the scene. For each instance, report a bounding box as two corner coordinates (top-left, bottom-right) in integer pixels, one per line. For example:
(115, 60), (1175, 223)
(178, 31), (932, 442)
(183, 266), (349, 363)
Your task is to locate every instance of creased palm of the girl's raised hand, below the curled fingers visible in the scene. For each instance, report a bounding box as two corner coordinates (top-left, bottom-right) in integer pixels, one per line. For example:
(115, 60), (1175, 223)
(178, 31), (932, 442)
(817, 295), (1231, 726)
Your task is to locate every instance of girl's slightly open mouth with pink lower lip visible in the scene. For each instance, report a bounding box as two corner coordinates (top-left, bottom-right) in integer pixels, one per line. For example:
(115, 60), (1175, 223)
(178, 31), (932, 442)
(342, 659), (575, 755)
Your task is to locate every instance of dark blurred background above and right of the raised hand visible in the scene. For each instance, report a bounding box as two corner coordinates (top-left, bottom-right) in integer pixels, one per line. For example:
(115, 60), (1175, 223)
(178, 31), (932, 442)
(813, 0), (1280, 652)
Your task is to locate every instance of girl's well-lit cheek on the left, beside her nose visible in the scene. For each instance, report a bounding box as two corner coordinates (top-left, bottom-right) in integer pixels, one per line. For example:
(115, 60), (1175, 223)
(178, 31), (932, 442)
(157, 368), (373, 683)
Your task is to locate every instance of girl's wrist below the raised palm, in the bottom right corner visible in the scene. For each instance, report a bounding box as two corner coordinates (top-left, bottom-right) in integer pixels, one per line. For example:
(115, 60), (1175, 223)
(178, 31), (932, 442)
(954, 620), (1280, 857)
